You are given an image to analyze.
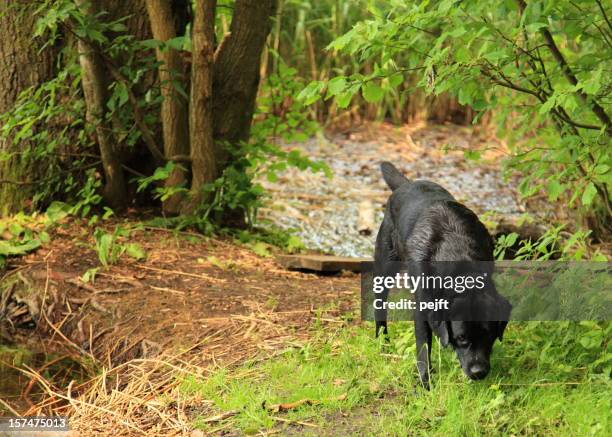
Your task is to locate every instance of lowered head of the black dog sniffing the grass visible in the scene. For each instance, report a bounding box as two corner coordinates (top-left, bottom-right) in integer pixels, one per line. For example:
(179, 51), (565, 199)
(433, 294), (512, 380)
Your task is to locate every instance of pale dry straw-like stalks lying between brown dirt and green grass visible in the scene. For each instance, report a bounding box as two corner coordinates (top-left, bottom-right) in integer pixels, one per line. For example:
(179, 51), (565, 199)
(17, 310), (338, 436)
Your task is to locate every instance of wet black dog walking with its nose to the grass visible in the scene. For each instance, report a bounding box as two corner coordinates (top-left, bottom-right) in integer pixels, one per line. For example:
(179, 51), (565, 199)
(374, 162), (512, 388)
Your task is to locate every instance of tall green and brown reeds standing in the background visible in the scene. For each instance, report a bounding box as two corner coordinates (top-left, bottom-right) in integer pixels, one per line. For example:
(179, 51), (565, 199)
(262, 0), (472, 126)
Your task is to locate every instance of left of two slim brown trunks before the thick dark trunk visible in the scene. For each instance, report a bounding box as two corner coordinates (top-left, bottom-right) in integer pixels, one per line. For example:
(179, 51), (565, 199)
(147, 0), (189, 214)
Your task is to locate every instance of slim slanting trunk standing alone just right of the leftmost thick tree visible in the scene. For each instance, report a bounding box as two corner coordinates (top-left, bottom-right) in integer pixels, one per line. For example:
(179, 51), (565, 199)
(78, 0), (127, 211)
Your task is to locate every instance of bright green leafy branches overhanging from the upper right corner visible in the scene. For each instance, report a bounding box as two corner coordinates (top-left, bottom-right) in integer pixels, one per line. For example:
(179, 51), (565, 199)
(300, 0), (612, 240)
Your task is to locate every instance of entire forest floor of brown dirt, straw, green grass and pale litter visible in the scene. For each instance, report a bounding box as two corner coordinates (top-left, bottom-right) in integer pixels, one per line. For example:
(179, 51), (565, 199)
(0, 121), (610, 436)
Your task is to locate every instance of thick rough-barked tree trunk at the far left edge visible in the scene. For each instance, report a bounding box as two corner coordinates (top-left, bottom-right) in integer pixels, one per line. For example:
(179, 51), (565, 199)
(0, 0), (57, 216)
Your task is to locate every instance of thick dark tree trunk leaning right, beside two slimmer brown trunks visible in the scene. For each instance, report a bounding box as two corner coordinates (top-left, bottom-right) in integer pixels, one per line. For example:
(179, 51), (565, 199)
(213, 0), (277, 169)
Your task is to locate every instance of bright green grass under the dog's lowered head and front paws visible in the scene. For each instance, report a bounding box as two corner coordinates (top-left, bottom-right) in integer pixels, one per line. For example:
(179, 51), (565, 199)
(182, 323), (611, 436)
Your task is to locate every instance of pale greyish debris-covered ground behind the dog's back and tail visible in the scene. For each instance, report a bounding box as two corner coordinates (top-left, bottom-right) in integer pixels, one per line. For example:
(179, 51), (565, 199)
(260, 125), (524, 256)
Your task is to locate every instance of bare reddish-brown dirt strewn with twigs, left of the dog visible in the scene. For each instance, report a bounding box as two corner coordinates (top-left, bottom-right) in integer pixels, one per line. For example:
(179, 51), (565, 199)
(4, 221), (358, 365)
